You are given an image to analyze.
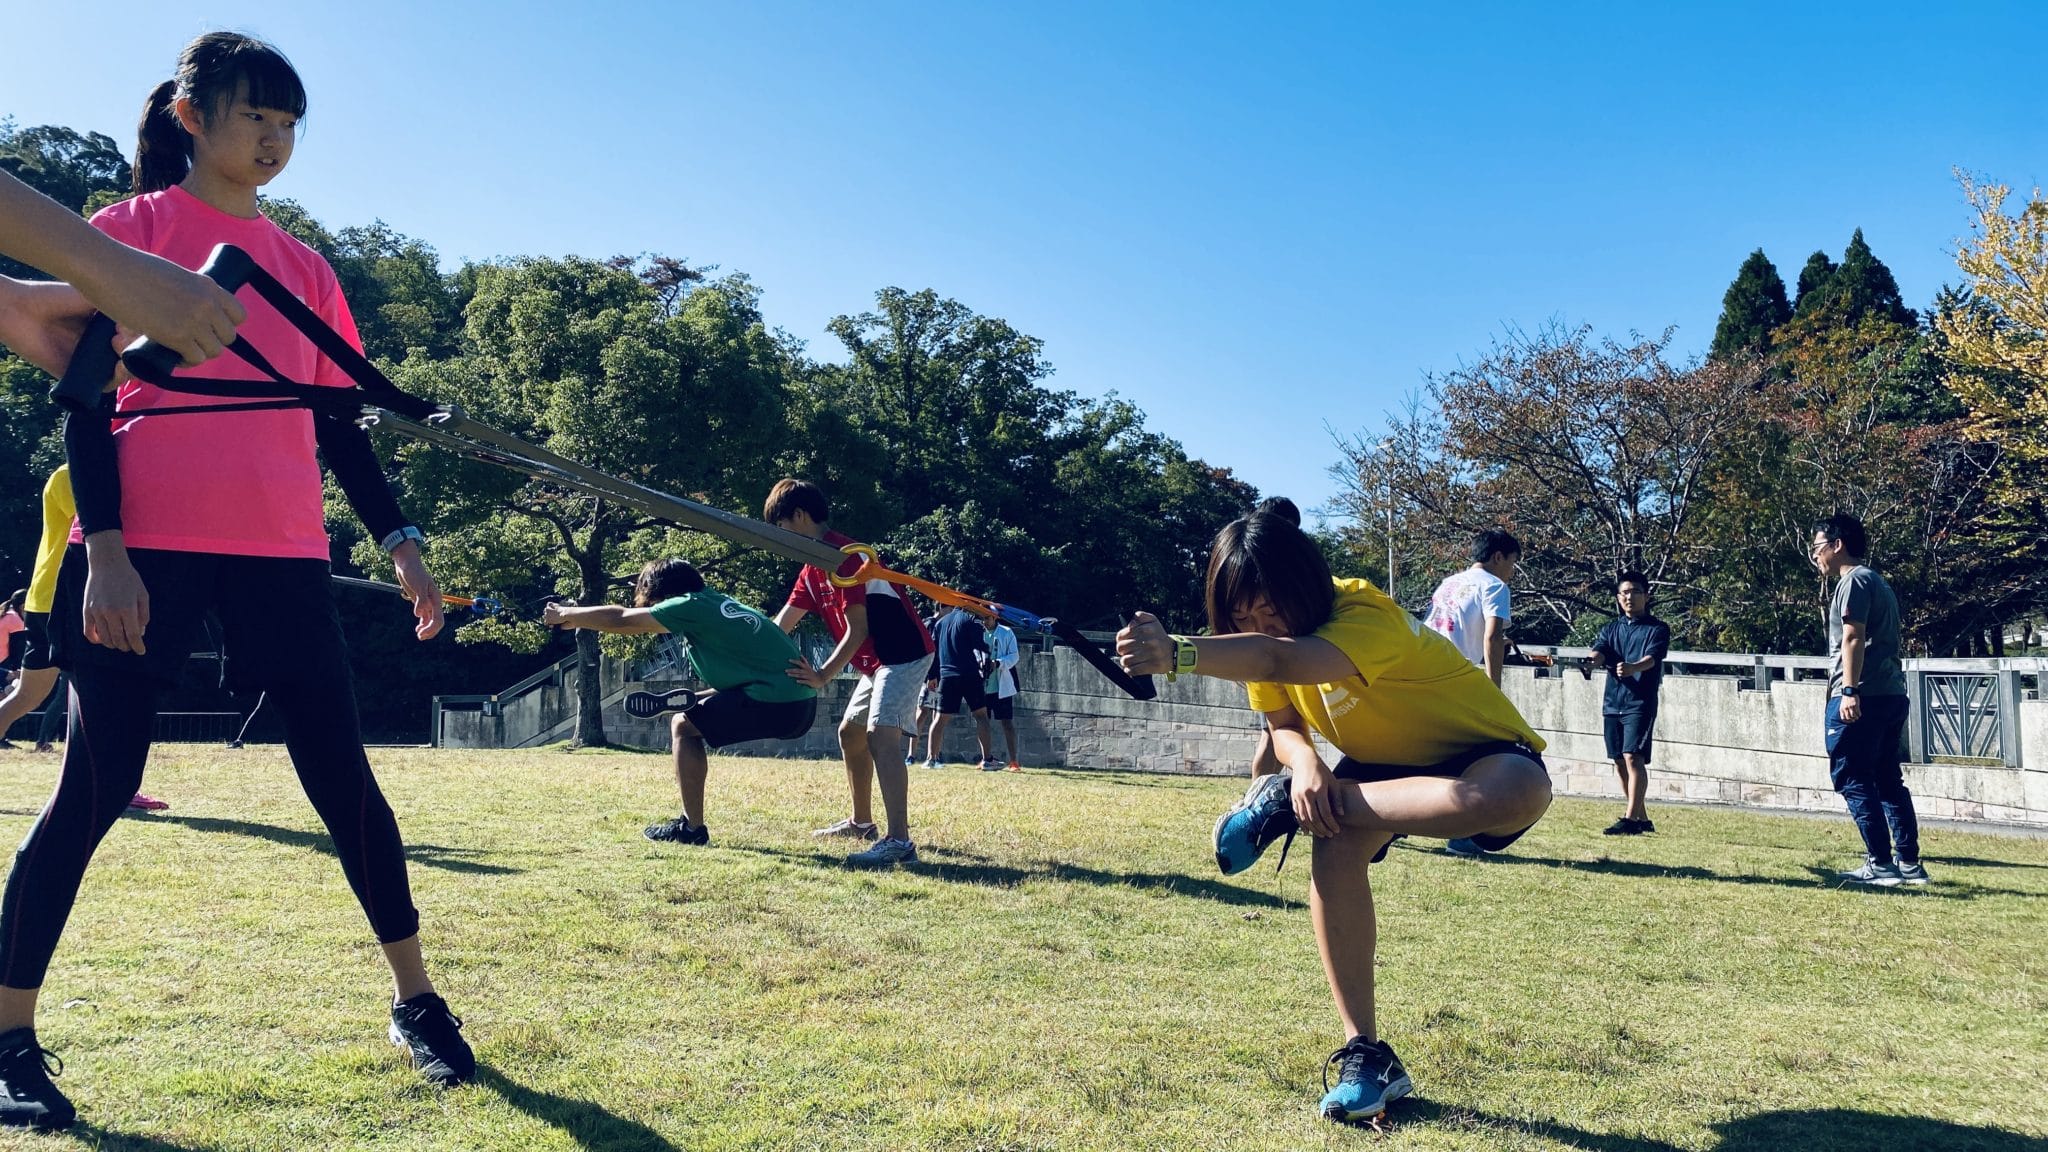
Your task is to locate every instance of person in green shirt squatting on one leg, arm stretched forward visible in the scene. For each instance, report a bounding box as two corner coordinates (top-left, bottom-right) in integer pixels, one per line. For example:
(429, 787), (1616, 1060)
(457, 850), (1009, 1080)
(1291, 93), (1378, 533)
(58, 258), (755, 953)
(541, 560), (817, 845)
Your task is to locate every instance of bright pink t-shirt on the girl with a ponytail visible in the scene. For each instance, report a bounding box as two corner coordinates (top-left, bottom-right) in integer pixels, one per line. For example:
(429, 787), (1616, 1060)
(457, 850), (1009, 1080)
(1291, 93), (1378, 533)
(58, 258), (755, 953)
(72, 187), (362, 560)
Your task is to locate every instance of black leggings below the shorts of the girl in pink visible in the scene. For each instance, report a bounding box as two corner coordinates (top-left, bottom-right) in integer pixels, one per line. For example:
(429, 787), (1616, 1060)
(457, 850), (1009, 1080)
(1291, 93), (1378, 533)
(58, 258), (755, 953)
(0, 660), (420, 988)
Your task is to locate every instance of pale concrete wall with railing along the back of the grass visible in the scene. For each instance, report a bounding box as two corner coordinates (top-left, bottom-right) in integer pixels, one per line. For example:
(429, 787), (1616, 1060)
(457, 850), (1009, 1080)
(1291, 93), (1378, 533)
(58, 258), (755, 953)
(438, 635), (2048, 824)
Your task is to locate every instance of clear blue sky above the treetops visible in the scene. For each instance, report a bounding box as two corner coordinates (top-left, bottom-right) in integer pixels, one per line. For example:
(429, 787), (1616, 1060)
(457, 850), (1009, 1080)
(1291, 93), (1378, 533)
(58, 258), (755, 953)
(0, 0), (2048, 520)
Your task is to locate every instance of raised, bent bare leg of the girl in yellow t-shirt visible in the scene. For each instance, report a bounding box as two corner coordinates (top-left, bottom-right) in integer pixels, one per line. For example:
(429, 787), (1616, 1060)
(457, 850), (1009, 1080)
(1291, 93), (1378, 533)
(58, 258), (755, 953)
(1337, 752), (1550, 838)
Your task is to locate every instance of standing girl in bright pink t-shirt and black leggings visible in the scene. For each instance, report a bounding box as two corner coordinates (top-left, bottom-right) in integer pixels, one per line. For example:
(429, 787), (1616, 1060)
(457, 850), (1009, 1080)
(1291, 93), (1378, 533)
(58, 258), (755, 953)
(0, 33), (475, 1127)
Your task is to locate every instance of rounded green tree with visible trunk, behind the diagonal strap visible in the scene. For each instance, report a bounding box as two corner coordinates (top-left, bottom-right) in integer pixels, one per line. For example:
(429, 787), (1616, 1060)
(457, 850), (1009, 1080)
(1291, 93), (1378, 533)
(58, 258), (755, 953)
(376, 258), (791, 744)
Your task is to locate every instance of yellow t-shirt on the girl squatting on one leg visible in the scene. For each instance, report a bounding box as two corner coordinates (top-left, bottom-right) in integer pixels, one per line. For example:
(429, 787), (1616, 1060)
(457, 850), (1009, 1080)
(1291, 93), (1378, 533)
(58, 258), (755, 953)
(1247, 580), (1542, 769)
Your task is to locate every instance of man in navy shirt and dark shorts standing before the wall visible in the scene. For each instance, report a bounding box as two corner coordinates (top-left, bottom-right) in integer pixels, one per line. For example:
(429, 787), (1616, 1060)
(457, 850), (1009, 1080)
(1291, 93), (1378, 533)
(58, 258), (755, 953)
(1593, 570), (1671, 836)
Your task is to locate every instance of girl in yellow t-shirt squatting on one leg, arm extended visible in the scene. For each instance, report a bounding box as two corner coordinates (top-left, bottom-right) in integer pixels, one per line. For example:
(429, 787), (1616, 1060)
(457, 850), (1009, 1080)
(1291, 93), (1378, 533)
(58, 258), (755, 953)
(1116, 512), (1550, 1121)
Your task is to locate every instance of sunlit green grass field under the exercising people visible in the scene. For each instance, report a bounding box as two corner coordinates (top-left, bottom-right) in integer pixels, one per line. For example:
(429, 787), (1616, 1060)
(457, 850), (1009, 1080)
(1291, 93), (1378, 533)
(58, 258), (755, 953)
(0, 748), (2048, 1152)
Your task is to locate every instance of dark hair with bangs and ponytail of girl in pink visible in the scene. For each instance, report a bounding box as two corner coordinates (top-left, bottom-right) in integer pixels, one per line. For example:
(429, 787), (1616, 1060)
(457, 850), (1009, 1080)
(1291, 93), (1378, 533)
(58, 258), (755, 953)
(133, 33), (305, 195)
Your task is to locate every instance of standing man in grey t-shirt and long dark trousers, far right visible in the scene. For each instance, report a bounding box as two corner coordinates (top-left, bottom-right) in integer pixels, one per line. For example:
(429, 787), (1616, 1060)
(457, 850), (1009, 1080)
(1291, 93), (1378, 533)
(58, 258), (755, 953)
(1810, 512), (1927, 888)
